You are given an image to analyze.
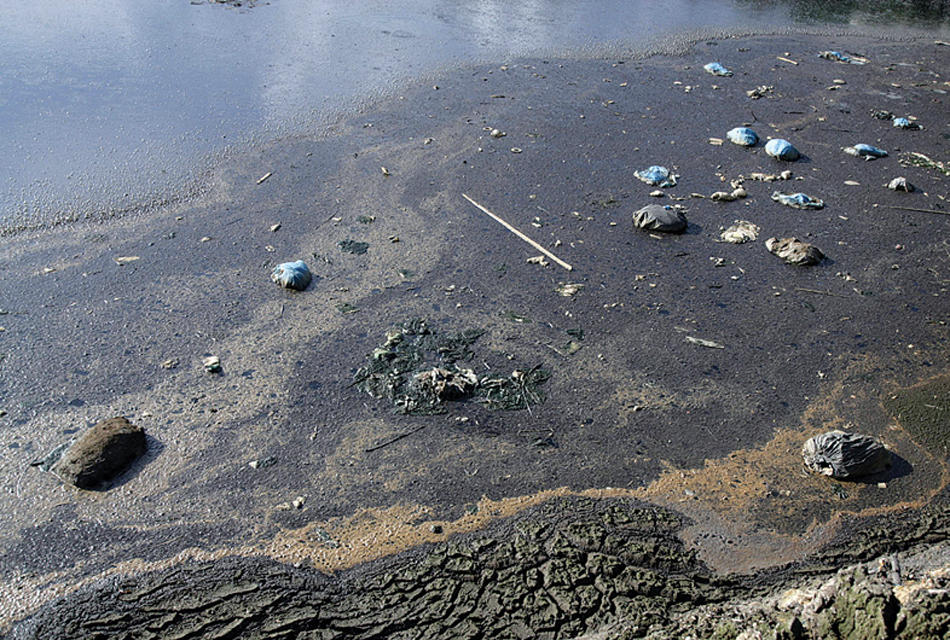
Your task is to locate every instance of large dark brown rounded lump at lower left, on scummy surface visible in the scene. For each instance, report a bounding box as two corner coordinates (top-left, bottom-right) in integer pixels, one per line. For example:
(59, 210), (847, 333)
(50, 417), (146, 489)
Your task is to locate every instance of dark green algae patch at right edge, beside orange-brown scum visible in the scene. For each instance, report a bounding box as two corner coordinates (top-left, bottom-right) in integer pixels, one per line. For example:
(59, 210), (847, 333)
(884, 375), (950, 458)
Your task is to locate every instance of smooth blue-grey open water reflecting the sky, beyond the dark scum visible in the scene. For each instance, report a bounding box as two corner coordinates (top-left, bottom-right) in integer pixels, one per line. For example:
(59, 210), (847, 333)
(0, 0), (950, 231)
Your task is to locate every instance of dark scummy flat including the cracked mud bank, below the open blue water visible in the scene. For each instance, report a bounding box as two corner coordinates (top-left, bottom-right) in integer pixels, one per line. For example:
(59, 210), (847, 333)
(0, 35), (950, 638)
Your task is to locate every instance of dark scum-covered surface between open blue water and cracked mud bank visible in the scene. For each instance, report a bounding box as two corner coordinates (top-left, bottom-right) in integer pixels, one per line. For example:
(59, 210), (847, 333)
(0, 31), (950, 636)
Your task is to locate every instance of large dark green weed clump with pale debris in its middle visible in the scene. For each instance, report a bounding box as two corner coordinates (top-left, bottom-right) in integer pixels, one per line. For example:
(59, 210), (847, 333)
(353, 319), (550, 415)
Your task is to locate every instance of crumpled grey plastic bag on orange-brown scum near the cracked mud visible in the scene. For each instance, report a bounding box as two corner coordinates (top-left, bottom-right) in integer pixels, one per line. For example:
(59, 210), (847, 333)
(802, 430), (891, 478)
